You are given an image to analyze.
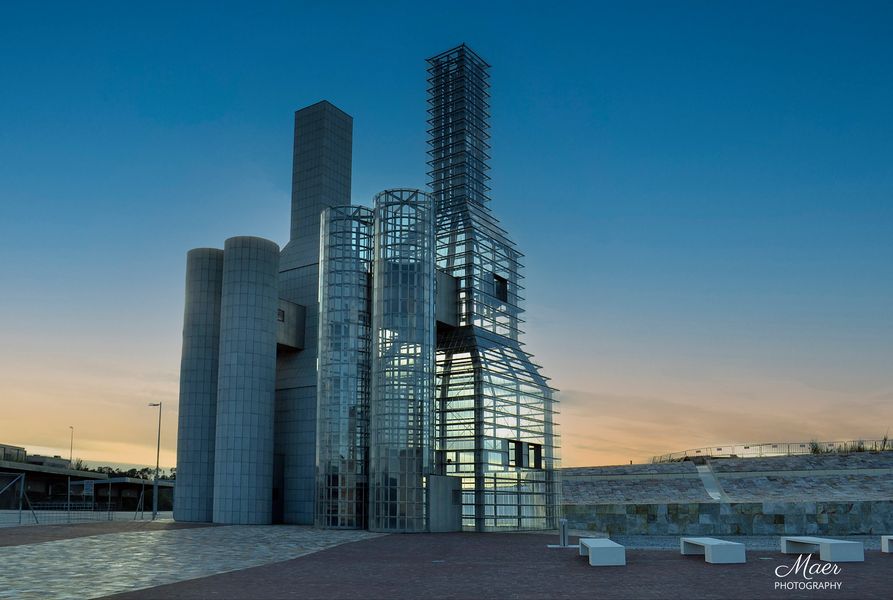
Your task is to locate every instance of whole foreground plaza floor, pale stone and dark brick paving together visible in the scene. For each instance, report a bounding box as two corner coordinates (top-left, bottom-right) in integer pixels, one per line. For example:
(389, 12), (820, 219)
(0, 522), (893, 600)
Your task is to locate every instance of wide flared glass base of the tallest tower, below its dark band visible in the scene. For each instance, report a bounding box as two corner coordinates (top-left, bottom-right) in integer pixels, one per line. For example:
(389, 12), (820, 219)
(437, 328), (559, 531)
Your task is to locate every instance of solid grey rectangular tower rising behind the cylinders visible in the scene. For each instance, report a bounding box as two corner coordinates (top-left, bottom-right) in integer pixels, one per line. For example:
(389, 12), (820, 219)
(273, 100), (353, 525)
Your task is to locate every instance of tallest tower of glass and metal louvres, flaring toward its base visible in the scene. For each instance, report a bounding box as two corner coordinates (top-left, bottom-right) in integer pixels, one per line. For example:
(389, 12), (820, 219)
(428, 44), (559, 531)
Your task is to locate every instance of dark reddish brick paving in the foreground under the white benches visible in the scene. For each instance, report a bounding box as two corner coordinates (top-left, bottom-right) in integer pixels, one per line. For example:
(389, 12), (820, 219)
(108, 533), (893, 600)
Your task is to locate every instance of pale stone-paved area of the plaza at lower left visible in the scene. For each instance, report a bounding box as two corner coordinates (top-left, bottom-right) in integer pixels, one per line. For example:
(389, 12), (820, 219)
(0, 523), (380, 600)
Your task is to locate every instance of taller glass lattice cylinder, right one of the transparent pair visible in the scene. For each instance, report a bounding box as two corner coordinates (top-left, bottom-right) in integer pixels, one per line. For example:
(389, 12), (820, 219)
(369, 189), (436, 532)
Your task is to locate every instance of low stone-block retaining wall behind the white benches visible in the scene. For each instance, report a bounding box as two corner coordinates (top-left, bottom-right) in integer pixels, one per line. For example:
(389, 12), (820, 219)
(563, 501), (893, 536)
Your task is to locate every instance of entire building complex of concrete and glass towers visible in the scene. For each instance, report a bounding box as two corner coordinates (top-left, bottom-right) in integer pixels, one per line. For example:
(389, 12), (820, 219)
(175, 45), (559, 532)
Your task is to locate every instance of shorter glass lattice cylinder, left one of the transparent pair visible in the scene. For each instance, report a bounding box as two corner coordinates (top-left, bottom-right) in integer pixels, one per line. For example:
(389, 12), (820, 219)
(315, 206), (372, 529)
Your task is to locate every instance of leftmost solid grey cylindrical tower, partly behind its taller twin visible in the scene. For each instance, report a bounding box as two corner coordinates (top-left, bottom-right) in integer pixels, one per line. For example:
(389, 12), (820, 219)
(174, 248), (223, 523)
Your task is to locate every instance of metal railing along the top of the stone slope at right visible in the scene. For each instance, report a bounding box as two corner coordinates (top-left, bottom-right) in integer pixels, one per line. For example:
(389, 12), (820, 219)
(651, 438), (893, 463)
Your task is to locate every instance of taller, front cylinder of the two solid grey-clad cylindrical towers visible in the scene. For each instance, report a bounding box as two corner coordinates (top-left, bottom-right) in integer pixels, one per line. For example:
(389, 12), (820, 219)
(214, 237), (279, 524)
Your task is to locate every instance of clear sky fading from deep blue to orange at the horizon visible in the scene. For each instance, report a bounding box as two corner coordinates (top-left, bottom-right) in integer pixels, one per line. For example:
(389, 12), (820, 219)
(0, 2), (893, 465)
